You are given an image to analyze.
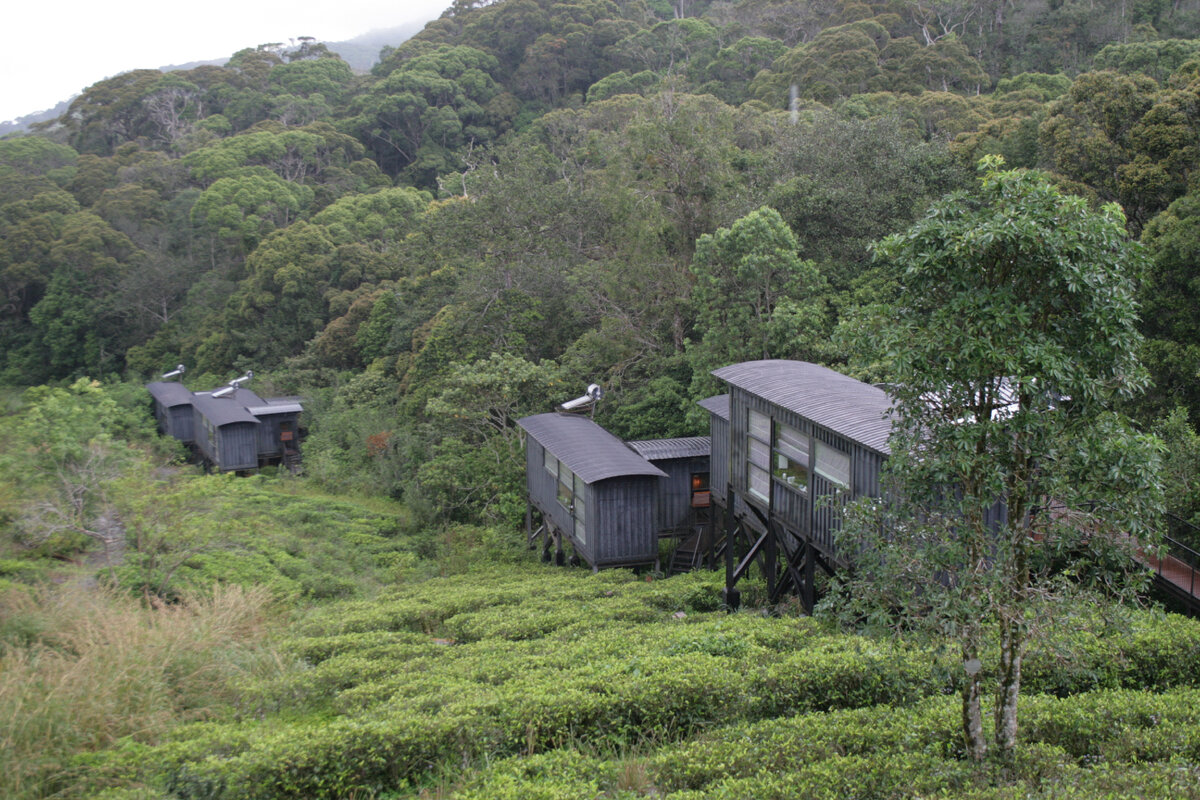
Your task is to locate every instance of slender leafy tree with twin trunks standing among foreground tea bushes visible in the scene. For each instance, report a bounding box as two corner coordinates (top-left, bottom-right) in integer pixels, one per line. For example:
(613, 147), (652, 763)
(842, 158), (1162, 763)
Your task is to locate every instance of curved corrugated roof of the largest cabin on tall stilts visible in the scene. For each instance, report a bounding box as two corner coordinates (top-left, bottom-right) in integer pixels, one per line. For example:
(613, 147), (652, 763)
(713, 360), (892, 455)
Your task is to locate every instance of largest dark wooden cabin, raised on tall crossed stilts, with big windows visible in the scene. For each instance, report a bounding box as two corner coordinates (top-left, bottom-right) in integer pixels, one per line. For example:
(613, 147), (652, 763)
(702, 360), (892, 609)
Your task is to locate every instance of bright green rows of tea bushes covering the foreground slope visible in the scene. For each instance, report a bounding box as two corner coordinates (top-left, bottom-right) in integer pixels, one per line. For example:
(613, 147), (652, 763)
(68, 563), (1200, 800)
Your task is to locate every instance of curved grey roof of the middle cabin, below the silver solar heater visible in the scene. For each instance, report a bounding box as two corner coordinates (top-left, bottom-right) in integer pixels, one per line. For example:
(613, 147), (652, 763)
(517, 413), (666, 483)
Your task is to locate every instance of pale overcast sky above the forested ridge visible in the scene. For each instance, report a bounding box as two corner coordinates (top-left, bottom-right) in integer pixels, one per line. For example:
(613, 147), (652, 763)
(0, 0), (450, 121)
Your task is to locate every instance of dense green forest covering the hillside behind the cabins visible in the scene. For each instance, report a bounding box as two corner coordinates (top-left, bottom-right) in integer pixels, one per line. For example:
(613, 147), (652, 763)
(0, 0), (1200, 521)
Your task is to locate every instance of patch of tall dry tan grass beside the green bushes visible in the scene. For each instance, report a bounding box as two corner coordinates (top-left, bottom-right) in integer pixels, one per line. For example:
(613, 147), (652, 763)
(0, 585), (281, 800)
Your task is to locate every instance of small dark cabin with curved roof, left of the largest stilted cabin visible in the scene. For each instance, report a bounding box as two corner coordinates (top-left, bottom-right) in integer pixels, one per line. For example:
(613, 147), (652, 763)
(518, 413), (667, 570)
